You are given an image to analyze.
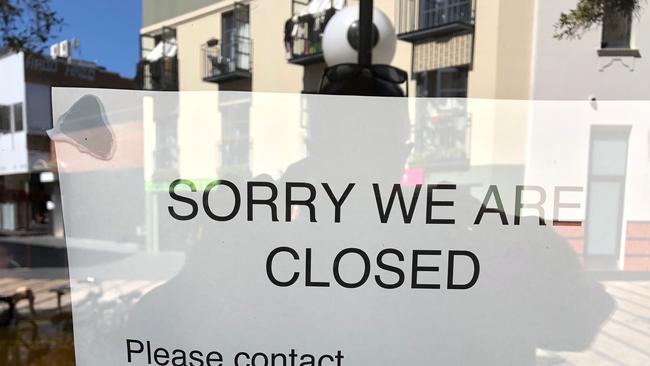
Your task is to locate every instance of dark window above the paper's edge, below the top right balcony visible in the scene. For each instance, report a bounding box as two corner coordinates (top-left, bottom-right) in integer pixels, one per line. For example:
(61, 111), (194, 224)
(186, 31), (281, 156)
(417, 67), (468, 98)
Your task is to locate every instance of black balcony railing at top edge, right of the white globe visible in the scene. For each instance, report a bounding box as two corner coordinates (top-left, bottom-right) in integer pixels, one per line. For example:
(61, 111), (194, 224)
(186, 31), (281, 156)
(397, 0), (474, 40)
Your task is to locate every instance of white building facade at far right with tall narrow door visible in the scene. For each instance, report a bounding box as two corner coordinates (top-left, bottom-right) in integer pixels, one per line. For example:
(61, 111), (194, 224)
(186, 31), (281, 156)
(526, 0), (650, 271)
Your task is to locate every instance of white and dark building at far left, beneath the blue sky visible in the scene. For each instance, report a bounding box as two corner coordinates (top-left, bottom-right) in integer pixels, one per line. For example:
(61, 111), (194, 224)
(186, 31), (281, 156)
(0, 48), (134, 254)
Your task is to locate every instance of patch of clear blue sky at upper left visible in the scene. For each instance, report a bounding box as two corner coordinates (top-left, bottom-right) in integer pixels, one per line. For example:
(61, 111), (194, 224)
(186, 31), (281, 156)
(48, 0), (142, 77)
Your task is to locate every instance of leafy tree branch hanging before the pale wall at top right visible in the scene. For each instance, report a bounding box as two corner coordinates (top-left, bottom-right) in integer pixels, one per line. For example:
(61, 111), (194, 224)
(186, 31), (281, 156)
(554, 0), (642, 39)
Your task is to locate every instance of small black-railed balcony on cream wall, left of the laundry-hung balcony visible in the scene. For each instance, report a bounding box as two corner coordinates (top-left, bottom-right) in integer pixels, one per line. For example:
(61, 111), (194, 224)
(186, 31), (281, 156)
(201, 36), (253, 82)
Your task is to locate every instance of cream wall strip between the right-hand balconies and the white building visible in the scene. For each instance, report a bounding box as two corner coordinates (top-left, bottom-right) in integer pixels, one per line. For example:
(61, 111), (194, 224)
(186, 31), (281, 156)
(468, 0), (535, 165)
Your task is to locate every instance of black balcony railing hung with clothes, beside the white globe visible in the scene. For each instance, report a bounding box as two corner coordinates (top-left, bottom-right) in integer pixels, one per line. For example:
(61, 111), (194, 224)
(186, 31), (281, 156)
(284, 0), (337, 65)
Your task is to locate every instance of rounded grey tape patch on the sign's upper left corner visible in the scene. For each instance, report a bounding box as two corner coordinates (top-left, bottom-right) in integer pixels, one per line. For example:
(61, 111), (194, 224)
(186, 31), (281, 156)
(47, 94), (116, 160)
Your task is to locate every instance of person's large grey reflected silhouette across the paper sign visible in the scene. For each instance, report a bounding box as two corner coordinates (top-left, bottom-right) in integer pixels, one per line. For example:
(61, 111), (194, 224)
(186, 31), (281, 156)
(128, 96), (614, 365)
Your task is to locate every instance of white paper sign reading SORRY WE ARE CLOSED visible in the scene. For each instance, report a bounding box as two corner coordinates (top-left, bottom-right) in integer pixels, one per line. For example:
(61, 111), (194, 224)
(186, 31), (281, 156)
(51, 88), (650, 366)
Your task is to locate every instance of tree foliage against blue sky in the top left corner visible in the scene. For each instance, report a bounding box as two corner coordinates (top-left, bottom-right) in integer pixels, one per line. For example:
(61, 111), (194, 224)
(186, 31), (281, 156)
(0, 0), (63, 52)
